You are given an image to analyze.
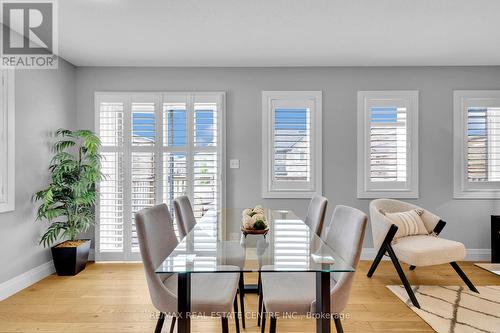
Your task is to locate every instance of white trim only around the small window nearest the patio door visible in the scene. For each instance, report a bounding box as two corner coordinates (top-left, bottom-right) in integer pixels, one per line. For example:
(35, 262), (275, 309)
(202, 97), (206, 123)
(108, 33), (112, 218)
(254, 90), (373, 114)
(262, 91), (323, 198)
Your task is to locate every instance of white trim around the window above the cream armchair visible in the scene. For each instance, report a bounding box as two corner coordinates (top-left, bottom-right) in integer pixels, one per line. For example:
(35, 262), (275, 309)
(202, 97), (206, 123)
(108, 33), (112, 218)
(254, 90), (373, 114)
(357, 90), (419, 199)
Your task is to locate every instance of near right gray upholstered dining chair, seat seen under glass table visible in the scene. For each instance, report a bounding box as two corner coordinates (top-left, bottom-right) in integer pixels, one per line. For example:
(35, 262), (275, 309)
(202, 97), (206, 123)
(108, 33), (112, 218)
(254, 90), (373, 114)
(262, 205), (368, 333)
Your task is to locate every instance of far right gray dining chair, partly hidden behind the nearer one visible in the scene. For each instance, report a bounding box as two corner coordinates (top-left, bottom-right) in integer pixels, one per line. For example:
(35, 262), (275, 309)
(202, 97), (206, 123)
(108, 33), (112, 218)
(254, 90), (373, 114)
(257, 195), (329, 326)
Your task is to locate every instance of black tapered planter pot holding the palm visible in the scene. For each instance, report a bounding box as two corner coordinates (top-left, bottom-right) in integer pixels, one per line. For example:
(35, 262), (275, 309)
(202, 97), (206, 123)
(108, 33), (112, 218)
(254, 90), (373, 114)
(51, 239), (90, 276)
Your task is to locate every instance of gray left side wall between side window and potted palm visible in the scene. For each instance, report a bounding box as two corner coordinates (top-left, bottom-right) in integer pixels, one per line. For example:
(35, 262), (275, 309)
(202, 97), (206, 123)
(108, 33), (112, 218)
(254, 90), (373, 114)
(0, 59), (76, 283)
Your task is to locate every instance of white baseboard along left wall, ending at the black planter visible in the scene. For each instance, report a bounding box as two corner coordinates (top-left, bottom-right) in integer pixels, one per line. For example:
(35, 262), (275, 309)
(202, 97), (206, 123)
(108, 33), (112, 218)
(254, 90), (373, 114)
(0, 260), (55, 301)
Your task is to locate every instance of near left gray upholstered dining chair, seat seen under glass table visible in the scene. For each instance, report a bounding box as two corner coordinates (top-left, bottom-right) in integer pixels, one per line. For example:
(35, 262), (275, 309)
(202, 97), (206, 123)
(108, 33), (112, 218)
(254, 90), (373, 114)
(135, 204), (239, 333)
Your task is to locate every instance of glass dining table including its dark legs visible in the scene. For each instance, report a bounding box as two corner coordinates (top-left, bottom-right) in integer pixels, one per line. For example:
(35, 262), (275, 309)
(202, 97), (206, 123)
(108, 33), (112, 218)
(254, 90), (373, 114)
(156, 209), (354, 333)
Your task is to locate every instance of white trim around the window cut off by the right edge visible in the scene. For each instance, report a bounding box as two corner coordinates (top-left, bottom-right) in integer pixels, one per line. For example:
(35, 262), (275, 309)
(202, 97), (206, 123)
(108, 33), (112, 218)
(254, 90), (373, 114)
(453, 90), (500, 199)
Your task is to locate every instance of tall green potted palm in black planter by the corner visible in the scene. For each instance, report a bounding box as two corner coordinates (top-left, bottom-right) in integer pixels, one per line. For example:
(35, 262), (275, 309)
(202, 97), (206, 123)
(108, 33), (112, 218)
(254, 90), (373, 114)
(33, 129), (103, 275)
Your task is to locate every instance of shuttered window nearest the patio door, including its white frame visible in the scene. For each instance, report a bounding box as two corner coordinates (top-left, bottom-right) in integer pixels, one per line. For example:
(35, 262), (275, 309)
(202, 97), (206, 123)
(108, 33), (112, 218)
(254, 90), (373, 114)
(262, 91), (322, 198)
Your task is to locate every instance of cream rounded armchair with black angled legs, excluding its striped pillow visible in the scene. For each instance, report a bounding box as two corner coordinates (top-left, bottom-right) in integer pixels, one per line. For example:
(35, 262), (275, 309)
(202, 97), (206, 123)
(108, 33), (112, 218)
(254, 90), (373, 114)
(367, 199), (478, 308)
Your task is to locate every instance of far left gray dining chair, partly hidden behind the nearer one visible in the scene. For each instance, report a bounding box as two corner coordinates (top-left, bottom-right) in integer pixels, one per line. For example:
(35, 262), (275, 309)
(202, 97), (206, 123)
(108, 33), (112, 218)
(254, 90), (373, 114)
(174, 195), (245, 328)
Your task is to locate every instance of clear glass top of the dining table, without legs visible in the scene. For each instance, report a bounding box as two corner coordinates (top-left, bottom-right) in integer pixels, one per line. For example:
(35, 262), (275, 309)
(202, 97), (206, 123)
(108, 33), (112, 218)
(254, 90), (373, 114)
(156, 209), (354, 273)
